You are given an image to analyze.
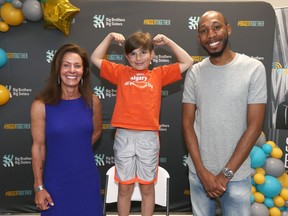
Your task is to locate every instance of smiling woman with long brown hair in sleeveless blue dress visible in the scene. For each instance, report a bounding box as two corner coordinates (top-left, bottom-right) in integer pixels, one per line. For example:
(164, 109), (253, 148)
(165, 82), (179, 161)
(31, 44), (103, 216)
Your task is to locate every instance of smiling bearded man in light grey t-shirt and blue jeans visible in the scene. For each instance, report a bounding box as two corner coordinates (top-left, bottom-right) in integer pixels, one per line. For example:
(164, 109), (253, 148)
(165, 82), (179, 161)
(182, 11), (267, 216)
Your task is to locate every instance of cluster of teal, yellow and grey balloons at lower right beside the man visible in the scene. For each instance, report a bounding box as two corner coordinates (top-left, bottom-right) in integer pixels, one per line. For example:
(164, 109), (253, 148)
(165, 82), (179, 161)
(250, 132), (288, 216)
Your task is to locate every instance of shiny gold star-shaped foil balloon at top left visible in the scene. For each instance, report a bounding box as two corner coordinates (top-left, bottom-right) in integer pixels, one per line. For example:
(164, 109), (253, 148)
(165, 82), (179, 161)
(41, 0), (80, 36)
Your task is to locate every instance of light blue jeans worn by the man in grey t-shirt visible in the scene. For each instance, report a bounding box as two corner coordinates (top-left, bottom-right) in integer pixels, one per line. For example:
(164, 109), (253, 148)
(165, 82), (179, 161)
(189, 171), (251, 216)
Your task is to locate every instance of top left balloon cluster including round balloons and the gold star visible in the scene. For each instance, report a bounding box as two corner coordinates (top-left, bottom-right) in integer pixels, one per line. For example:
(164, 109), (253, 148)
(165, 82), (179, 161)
(0, 0), (80, 36)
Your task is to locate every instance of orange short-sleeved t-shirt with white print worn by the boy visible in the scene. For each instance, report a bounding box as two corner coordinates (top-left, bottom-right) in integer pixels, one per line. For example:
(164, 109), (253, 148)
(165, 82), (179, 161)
(100, 60), (182, 130)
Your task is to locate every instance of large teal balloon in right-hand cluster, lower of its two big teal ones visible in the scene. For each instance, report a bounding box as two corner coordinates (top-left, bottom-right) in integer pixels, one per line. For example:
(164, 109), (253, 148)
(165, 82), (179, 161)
(256, 175), (282, 198)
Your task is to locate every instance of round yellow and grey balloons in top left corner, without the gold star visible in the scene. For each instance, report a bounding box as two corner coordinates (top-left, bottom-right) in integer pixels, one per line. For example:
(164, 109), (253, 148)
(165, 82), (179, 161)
(0, 0), (43, 32)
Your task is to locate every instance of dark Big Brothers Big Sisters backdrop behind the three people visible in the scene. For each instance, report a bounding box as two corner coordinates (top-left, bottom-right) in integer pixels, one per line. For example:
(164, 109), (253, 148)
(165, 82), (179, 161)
(0, 0), (276, 213)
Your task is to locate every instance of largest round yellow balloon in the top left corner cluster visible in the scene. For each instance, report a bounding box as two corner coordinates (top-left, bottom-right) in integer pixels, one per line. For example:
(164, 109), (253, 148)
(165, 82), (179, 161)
(1, 2), (24, 26)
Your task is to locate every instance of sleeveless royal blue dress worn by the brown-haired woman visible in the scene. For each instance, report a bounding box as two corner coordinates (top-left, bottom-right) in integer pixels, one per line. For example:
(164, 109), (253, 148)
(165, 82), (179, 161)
(41, 98), (103, 216)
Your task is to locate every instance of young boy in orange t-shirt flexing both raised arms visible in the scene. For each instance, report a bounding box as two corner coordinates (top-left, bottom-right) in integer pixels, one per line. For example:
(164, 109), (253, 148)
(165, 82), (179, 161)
(91, 31), (193, 216)
